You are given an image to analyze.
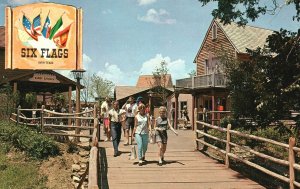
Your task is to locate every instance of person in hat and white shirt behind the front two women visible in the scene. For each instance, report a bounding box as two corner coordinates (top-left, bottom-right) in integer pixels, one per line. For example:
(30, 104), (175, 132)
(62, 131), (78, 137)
(122, 96), (137, 145)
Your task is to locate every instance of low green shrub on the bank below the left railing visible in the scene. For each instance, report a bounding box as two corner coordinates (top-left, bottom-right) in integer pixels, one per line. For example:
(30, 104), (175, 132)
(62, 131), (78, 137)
(0, 121), (59, 159)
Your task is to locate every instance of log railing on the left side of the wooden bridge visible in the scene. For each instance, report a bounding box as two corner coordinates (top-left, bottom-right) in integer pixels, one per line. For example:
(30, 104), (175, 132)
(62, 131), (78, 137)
(10, 106), (100, 189)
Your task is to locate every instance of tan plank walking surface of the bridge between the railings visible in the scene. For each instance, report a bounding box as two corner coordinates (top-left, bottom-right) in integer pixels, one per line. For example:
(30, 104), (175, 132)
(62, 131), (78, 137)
(100, 130), (264, 189)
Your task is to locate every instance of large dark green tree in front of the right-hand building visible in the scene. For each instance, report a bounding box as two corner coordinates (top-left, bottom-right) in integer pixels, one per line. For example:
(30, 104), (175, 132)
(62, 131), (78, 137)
(223, 30), (300, 132)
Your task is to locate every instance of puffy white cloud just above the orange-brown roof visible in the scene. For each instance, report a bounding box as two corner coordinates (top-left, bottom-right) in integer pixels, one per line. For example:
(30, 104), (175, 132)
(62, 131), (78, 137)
(139, 54), (189, 83)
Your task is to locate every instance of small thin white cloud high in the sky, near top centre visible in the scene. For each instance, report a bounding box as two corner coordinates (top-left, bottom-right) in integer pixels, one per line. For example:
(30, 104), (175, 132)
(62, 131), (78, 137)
(138, 9), (176, 24)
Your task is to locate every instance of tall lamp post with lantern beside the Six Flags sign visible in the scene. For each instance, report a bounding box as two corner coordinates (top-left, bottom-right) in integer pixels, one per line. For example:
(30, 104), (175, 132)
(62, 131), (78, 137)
(71, 70), (85, 142)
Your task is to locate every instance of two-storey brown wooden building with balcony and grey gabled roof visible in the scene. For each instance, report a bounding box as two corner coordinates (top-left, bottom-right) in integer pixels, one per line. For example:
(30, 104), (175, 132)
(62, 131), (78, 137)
(174, 19), (273, 128)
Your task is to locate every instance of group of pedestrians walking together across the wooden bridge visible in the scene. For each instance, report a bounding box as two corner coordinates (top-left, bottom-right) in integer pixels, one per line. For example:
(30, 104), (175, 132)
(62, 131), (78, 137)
(101, 97), (178, 166)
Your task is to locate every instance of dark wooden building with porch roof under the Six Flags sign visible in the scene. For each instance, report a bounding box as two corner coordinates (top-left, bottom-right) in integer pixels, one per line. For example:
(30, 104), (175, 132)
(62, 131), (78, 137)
(0, 26), (78, 109)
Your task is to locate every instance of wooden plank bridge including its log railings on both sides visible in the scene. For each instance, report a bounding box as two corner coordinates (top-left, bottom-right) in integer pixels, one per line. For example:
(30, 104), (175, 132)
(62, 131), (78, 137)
(10, 107), (300, 189)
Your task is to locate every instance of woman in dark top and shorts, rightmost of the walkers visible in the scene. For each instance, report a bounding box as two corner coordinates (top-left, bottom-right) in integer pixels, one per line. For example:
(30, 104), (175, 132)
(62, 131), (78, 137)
(154, 106), (178, 166)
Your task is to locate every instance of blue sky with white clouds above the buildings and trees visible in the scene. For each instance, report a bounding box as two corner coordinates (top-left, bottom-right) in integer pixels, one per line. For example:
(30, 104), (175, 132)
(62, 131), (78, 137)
(0, 0), (300, 85)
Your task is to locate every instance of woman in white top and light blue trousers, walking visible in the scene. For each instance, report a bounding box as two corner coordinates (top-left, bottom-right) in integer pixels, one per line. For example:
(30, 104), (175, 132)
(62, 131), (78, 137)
(133, 104), (151, 166)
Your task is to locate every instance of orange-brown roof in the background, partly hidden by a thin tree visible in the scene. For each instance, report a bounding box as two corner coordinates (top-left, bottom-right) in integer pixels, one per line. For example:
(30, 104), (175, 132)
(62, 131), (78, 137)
(136, 74), (173, 88)
